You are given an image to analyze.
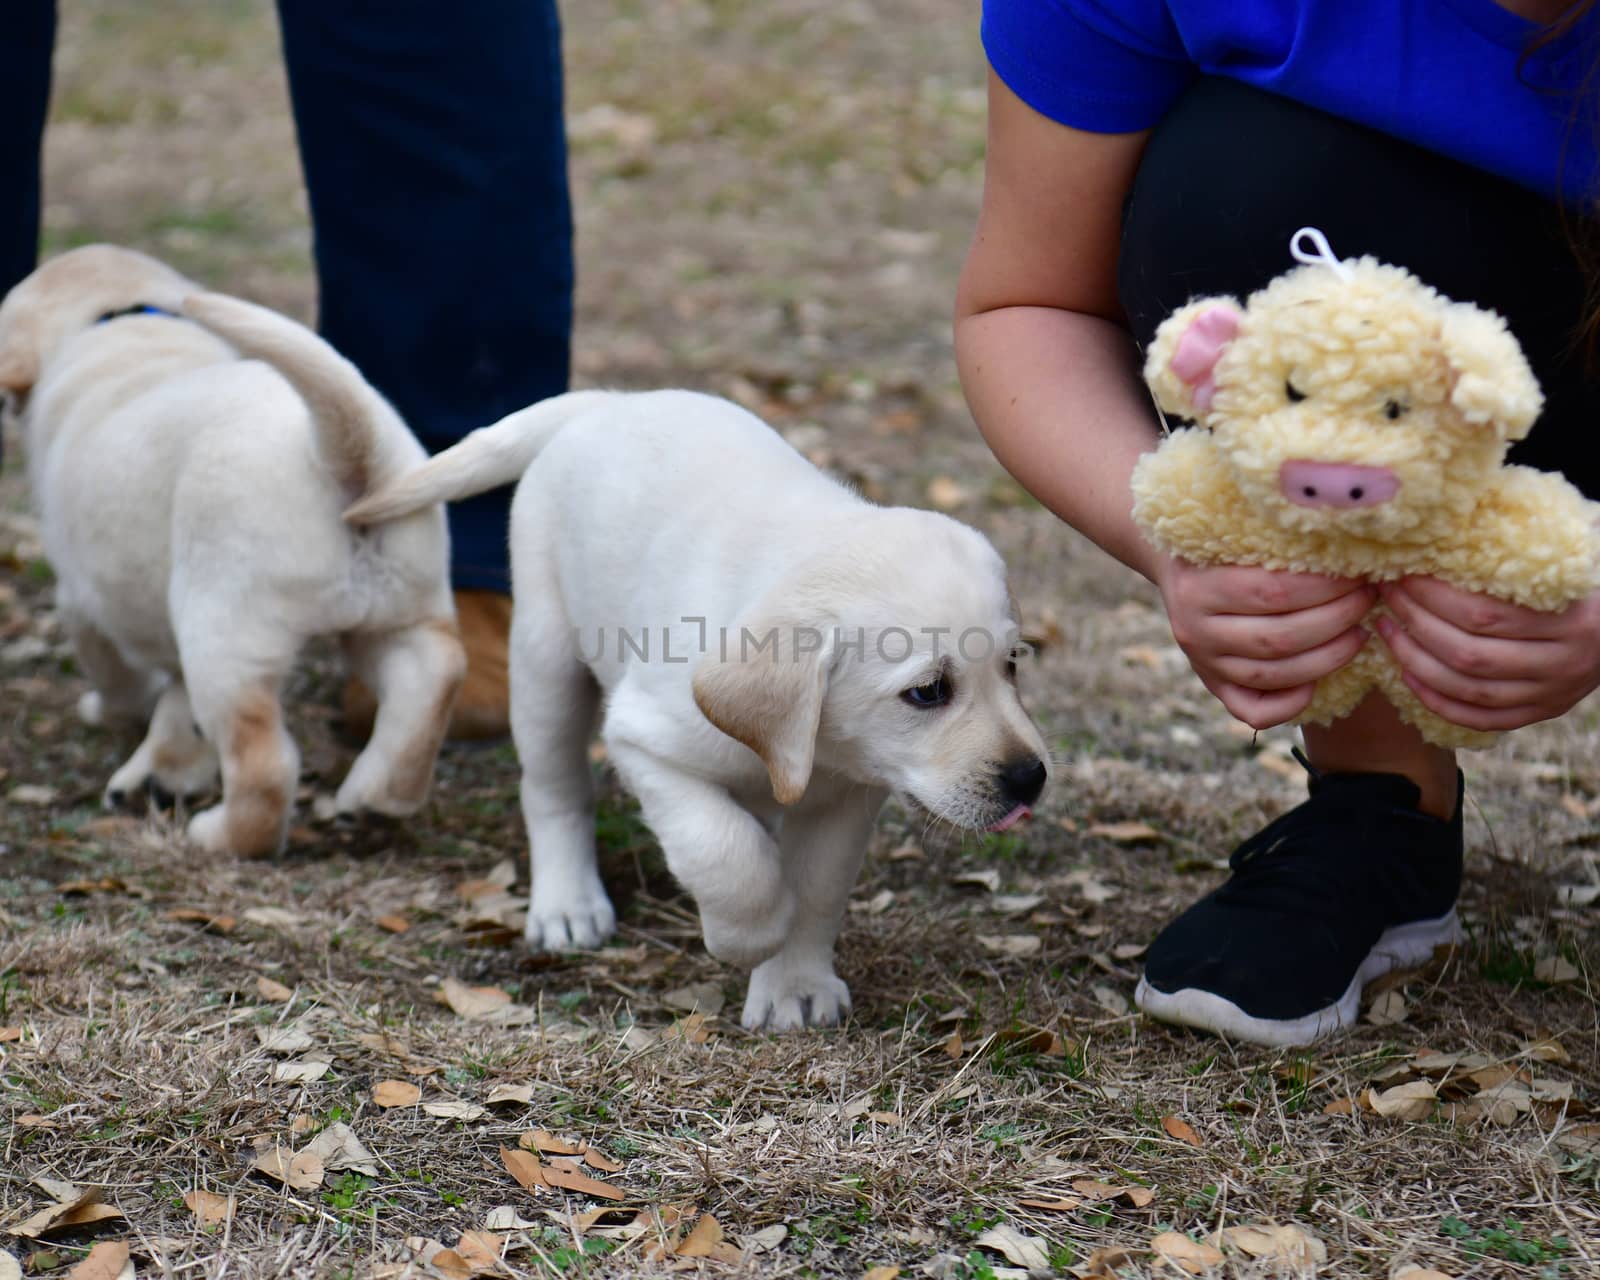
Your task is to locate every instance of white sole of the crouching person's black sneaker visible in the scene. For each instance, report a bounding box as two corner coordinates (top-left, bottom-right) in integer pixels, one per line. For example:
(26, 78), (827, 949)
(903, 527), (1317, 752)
(1133, 907), (1461, 1048)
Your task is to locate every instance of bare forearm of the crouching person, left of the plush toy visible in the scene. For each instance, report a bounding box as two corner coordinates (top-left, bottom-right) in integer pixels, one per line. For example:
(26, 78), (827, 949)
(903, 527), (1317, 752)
(955, 307), (1158, 578)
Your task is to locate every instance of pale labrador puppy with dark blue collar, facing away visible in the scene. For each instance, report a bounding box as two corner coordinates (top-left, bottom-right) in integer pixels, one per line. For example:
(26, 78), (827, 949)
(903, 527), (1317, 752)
(0, 245), (464, 854)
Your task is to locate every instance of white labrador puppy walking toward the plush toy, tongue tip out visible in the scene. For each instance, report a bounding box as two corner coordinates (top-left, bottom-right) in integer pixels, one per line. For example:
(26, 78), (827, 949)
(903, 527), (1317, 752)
(346, 390), (1046, 1029)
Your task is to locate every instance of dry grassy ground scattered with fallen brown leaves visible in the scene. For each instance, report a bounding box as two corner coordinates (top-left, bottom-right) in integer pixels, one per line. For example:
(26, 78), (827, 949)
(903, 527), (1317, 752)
(0, 0), (1600, 1280)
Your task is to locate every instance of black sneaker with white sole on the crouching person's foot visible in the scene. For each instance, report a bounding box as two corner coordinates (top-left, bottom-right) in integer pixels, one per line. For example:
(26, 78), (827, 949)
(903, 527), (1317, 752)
(1134, 752), (1461, 1045)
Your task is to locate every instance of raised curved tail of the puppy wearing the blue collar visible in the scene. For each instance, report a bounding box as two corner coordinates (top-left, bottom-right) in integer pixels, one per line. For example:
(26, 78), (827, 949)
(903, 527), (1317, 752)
(182, 293), (395, 496)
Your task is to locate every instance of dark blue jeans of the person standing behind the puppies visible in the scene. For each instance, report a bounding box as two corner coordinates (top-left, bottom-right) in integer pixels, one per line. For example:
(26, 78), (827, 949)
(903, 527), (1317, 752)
(0, 0), (573, 590)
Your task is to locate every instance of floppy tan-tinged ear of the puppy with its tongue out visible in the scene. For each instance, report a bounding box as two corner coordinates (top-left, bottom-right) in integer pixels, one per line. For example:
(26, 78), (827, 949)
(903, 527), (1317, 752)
(693, 614), (834, 805)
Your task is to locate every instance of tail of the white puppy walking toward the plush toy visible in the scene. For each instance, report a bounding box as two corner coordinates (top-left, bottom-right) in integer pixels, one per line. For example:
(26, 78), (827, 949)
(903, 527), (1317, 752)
(344, 390), (626, 525)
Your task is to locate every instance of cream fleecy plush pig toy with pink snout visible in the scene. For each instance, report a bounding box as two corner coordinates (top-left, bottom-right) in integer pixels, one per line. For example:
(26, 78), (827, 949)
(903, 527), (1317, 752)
(1133, 227), (1600, 747)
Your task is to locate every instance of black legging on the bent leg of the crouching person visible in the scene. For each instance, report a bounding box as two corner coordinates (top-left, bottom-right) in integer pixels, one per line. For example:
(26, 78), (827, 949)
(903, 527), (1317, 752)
(1118, 78), (1600, 498)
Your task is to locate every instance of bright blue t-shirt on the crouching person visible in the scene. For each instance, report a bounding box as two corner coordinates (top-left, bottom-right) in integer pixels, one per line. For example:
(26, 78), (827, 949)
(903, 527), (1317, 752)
(982, 0), (1600, 203)
